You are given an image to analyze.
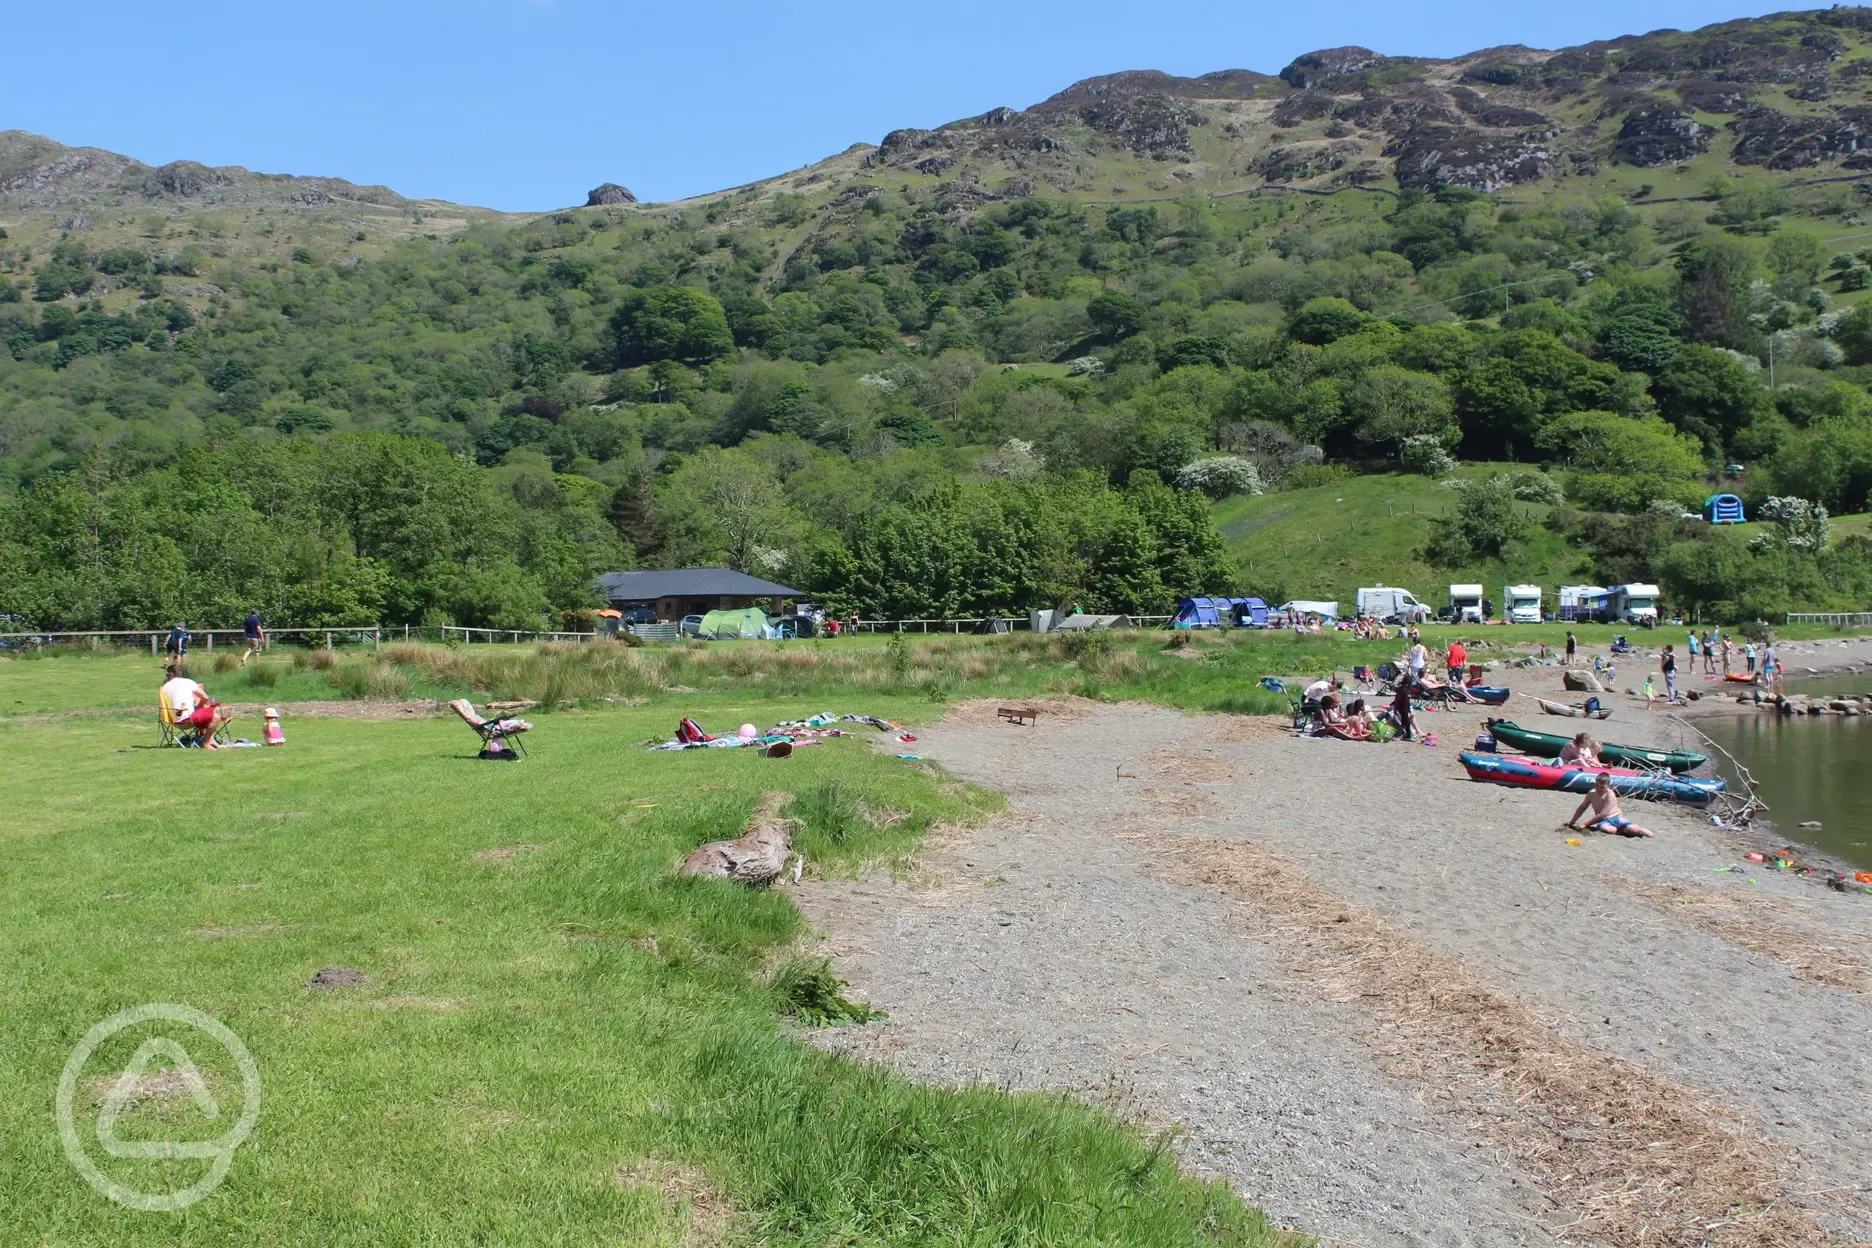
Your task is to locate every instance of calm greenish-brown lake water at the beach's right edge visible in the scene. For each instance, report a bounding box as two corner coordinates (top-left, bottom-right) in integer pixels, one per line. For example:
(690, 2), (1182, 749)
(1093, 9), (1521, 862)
(1696, 675), (1872, 868)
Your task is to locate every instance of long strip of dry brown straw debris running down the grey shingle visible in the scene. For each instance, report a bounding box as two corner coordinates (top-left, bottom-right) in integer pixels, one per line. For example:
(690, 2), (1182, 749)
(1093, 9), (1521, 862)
(1121, 831), (1840, 1248)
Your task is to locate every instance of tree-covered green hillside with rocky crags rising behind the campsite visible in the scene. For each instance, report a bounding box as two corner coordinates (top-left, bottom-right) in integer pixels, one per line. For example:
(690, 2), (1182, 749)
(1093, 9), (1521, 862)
(0, 7), (1872, 627)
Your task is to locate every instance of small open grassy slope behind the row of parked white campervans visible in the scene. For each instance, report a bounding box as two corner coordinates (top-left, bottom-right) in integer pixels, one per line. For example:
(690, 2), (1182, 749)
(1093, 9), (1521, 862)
(1215, 466), (1580, 606)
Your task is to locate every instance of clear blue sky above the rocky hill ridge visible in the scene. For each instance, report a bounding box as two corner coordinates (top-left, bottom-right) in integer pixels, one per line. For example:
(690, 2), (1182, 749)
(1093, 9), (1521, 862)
(0, 0), (1786, 211)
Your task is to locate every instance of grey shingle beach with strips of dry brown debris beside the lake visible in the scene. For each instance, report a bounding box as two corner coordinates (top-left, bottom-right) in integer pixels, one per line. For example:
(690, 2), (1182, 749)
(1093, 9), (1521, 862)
(799, 684), (1872, 1248)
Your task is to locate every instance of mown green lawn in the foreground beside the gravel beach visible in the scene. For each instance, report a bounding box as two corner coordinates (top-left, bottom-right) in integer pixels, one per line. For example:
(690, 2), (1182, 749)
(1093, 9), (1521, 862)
(0, 673), (1295, 1244)
